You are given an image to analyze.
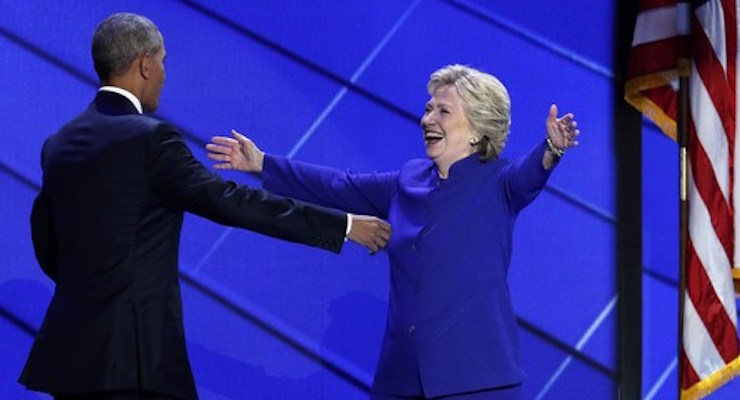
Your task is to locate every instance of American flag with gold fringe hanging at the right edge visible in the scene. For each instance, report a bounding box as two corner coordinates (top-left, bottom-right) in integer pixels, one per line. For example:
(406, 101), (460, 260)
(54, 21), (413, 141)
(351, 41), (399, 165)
(625, 0), (740, 399)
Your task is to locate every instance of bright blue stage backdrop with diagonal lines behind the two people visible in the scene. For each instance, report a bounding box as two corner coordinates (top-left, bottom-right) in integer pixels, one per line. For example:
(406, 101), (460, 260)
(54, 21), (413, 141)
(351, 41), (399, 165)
(0, 0), (738, 400)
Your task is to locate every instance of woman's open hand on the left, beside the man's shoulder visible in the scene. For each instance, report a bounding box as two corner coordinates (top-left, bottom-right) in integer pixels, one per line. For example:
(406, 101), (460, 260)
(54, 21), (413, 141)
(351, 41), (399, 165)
(206, 129), (265, 174)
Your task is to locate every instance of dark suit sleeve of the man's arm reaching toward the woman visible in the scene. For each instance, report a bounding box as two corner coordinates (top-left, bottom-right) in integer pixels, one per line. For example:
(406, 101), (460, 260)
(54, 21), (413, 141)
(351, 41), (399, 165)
(147, 124), (347, 253)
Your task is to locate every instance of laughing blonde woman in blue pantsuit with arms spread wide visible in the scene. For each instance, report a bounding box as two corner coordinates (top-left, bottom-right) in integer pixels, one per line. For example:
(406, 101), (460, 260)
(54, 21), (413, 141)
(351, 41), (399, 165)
(207, 65), (579, 400)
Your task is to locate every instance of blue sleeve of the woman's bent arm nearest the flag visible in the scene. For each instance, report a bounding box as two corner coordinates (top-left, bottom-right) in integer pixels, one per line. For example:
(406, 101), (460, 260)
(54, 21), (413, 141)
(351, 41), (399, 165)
(502, 140), (554, 213)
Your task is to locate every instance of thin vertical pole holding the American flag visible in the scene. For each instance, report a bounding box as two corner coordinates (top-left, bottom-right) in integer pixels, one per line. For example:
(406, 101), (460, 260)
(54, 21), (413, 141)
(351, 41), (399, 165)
(676, 2), (691, 400)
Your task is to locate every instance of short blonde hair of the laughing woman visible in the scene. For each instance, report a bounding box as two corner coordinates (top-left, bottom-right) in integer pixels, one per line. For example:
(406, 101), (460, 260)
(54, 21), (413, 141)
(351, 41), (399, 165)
(427, 64), (511, 161)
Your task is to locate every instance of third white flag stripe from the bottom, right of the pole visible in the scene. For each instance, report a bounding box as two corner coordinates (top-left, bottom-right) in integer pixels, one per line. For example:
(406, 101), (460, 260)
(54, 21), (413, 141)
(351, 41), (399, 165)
(689, 63), (730, 204)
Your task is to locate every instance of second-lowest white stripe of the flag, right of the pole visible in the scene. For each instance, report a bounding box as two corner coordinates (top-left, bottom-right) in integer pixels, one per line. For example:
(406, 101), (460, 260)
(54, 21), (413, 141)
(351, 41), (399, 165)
(689, 166), (737, 326)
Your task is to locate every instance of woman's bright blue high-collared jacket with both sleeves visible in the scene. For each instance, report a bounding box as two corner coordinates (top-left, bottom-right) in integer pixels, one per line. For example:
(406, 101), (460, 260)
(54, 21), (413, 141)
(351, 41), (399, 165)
(262, 141), (550, 397)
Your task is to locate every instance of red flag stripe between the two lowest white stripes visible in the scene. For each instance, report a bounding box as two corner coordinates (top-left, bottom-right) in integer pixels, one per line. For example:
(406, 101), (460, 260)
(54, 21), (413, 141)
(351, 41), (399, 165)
(686, 239), (738, 363)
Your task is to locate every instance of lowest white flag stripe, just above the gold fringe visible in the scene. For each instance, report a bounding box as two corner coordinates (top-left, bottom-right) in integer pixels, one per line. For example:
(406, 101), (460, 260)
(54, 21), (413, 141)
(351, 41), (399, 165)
(683, 294), (725, 380)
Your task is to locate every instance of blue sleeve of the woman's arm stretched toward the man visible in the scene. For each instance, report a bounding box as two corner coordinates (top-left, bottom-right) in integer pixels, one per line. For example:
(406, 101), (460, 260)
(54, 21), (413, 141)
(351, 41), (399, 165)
(262, 154), (398, 219)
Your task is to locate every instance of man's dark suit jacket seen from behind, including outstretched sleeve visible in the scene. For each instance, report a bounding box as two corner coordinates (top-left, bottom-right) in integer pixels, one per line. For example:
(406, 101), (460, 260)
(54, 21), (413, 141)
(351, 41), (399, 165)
(20, 92), (346, 399)
